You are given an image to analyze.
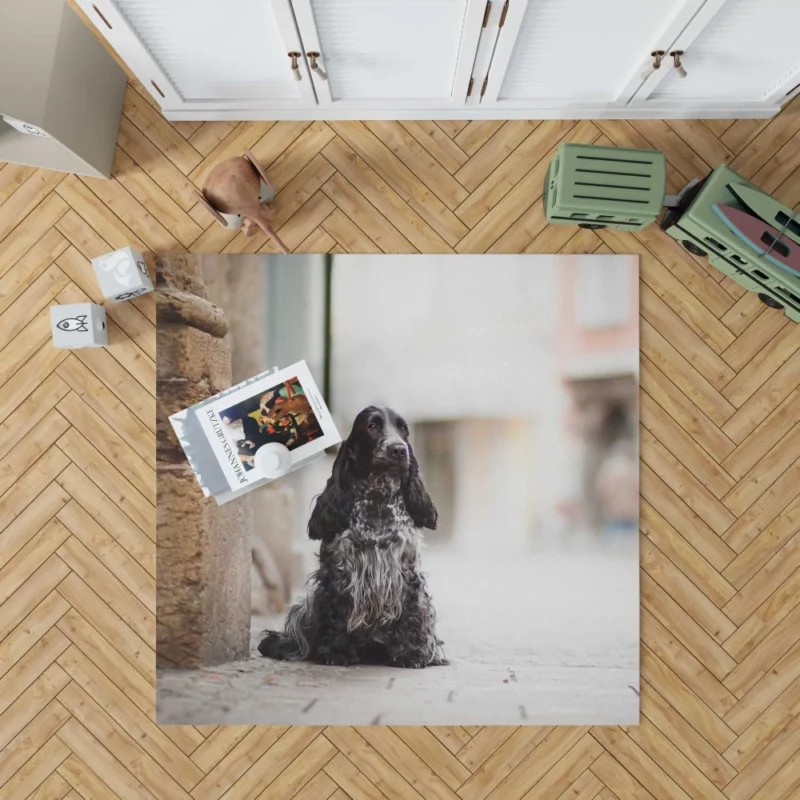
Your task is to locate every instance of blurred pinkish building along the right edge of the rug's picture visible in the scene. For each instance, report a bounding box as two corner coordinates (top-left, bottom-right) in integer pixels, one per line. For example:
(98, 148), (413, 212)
(555, 256), (639, 536)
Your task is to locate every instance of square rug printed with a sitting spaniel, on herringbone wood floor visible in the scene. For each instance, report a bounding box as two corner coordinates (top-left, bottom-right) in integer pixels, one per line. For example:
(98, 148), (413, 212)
(156, 255), (639, 725)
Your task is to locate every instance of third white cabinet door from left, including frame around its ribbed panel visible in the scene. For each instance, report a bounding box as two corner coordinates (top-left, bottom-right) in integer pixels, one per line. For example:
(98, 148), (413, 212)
(481, 0), (708, 110)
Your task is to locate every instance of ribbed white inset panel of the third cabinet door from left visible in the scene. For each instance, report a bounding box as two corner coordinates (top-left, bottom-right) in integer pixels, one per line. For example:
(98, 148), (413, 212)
(499, 0), (680, 102)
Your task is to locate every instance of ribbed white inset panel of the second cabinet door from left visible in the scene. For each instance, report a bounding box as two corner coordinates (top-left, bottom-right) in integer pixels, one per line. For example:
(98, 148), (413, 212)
(311, 0), (467, 100)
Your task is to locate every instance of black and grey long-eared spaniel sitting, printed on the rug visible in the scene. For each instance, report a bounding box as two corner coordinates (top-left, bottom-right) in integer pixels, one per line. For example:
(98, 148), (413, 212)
(258, 406), (448, 669)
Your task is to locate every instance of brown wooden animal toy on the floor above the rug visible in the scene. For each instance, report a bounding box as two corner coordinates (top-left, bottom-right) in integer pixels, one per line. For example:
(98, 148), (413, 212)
(199, 150), (289, 253)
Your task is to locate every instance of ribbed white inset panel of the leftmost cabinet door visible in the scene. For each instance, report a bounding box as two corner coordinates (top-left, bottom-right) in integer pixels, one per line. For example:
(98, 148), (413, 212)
(116, 0), (297, 100)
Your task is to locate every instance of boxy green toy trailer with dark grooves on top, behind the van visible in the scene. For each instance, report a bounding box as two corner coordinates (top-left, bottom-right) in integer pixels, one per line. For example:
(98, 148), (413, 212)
(543, 144), (667, 231)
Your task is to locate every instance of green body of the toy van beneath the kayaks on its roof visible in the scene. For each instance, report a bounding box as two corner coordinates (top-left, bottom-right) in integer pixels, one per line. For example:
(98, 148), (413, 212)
(661, 166), (800, 322)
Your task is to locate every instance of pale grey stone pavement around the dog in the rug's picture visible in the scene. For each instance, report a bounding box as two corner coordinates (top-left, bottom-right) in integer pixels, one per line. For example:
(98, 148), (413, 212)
(157, 544), (639, 725)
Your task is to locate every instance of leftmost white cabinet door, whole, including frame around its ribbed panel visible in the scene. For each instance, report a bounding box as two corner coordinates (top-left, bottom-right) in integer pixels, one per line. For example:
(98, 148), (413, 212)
(77, 0), (316, 112)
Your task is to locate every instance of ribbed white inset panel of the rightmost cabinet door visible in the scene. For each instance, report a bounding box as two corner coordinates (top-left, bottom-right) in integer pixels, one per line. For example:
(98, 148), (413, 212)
(650, 0), (800, 101)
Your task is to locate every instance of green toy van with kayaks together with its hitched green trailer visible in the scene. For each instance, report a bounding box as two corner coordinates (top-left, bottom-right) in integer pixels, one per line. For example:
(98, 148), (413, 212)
(542, 143), (800, 322)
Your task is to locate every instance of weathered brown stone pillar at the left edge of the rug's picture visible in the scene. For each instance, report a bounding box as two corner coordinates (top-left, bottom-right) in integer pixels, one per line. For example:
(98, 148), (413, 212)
(156, 255), (253, 668)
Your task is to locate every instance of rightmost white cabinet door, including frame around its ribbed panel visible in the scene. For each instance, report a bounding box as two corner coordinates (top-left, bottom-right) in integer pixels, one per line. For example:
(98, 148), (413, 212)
(632, 0), (800, 112)
